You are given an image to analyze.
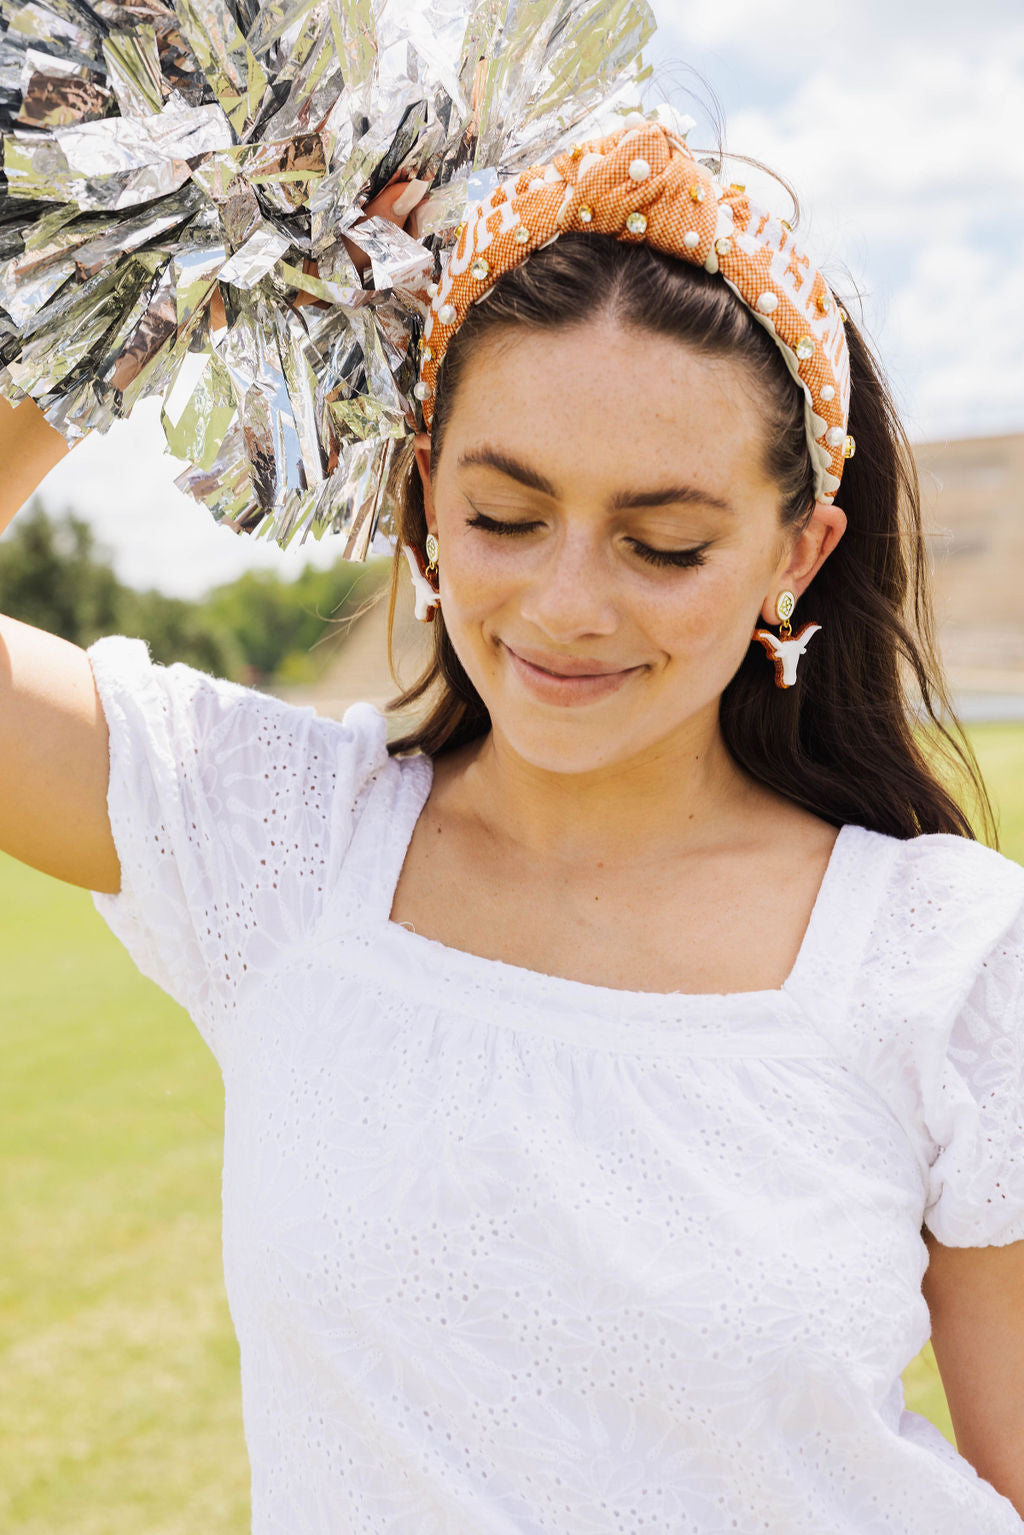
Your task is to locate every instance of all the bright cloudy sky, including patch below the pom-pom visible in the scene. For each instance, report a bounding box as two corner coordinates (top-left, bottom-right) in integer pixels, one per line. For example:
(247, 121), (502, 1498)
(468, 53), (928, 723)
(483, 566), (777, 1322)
(23, 0), (1024, 597)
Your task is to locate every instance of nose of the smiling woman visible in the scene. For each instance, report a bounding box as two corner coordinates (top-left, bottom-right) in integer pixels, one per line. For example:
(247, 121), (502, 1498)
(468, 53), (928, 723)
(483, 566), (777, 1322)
(520, 530), (619, 645)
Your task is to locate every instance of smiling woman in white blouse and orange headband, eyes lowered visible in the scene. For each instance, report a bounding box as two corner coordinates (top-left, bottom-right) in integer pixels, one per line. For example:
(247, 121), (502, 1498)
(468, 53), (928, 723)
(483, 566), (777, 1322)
(0, 121), (1024, 1535)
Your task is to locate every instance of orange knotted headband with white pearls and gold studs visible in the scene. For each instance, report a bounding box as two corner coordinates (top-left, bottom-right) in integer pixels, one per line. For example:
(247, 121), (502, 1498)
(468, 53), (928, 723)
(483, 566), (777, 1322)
(415, 117), (854, 502)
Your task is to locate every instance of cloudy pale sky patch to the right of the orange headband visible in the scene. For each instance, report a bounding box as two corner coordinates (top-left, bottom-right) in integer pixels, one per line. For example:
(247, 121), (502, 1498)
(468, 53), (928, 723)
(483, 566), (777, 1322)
(647, 0), (1024, 439)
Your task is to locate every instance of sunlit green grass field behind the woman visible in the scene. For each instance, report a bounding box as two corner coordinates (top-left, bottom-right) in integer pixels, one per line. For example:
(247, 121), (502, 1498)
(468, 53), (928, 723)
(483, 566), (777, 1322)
(0, 726), (1024, 1535)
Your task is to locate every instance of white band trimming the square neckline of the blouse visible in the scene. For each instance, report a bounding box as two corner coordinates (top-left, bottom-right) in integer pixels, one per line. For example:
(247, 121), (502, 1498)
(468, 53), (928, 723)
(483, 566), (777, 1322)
(375, 755), (872, 1019)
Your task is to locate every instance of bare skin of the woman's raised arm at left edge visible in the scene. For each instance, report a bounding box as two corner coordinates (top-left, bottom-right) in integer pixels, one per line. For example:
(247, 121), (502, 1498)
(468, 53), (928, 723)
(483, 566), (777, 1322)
(0, 399), (121, 892)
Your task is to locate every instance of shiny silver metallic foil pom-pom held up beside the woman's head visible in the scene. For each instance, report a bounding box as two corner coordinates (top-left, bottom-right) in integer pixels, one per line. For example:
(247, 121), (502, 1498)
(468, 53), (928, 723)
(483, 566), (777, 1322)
(0, 0), (654, 559)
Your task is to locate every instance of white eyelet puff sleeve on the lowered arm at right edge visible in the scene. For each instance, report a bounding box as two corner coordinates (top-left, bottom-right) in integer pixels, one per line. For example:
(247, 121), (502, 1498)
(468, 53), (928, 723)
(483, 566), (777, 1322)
(924, 890), (1024, 1246)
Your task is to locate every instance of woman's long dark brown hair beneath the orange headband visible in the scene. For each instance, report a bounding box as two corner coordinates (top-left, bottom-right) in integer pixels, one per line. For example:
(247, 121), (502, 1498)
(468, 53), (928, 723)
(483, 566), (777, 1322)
(388, 233), (996, 846)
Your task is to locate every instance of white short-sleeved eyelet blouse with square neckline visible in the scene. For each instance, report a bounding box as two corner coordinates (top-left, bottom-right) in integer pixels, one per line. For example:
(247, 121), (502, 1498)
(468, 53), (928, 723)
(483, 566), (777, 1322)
(89, 637), (1024, 1535)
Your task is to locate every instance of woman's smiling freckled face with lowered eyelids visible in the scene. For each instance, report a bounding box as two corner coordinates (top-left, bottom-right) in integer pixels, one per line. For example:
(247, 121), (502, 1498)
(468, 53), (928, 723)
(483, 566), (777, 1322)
(418, 321), (841, 772)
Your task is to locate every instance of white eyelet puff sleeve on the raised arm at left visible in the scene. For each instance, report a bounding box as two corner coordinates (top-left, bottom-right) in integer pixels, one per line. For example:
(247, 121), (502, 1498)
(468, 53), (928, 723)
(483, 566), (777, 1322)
(88, 635), (387, 1055)
